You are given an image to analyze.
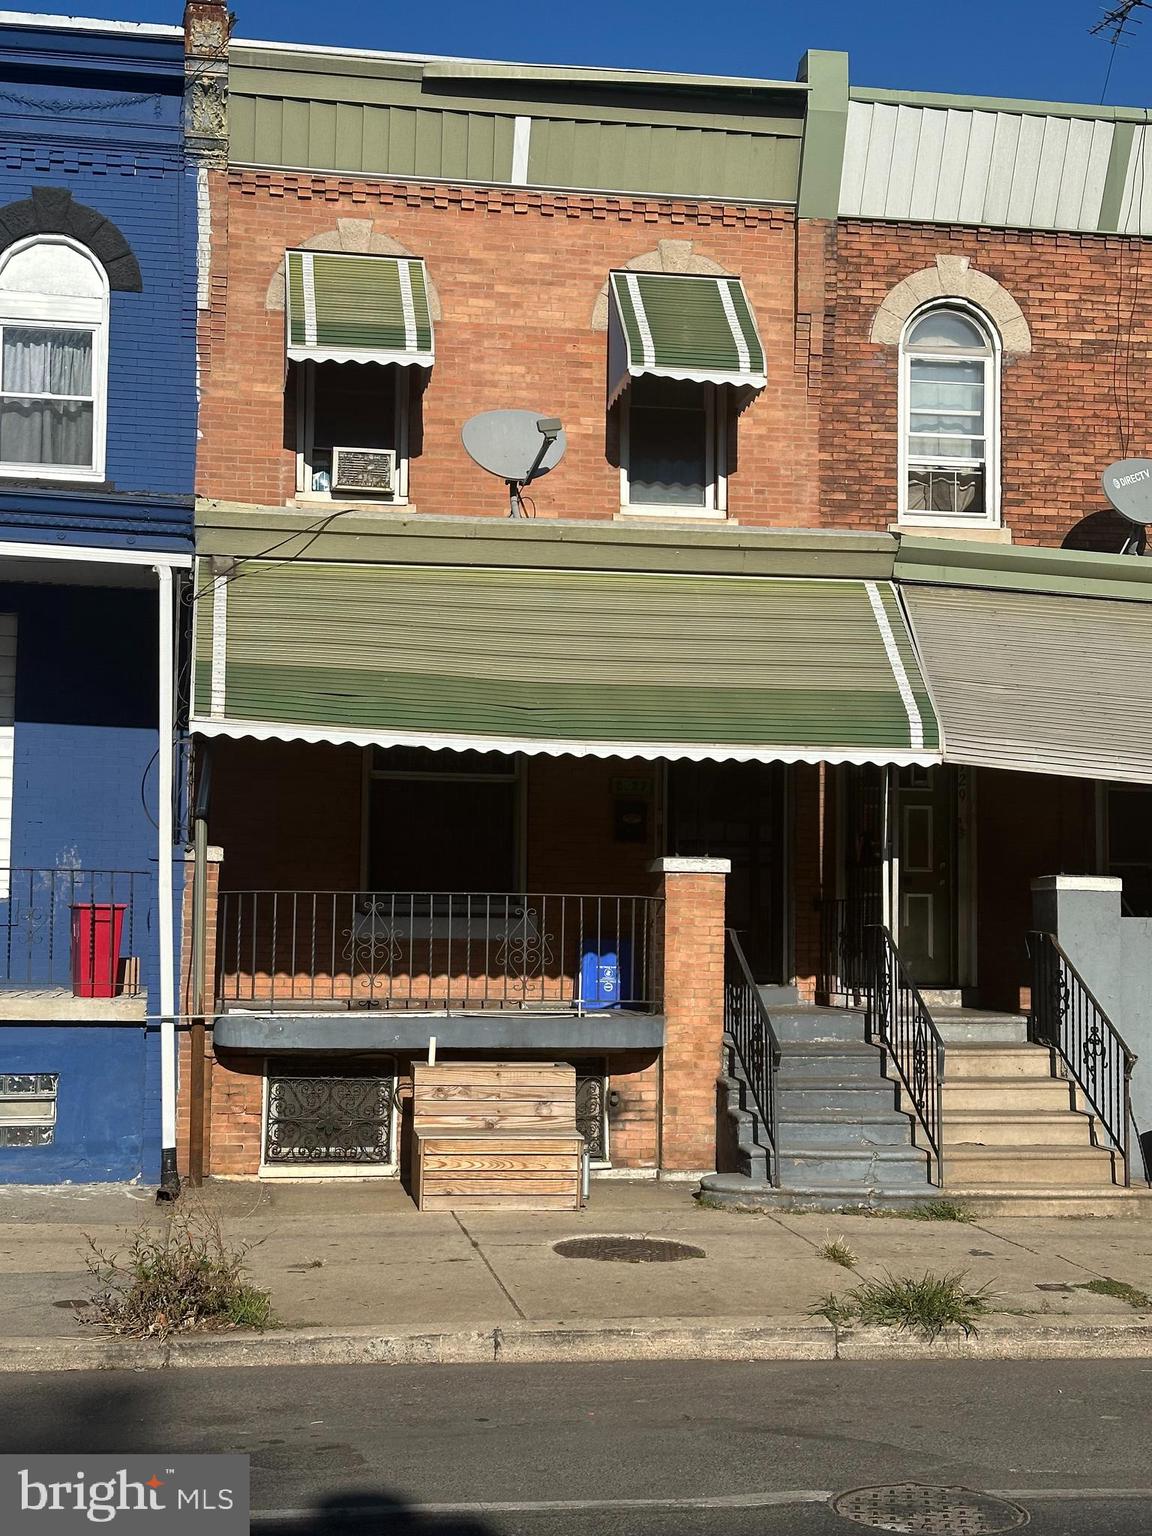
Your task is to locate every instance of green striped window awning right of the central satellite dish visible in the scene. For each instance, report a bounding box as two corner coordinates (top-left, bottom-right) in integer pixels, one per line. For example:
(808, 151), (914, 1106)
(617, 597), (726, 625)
(608, 272), (766, 404)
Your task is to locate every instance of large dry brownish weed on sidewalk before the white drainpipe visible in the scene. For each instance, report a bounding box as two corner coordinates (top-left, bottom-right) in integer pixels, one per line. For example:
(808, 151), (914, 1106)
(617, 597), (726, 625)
(81, 1195), (275, 1339)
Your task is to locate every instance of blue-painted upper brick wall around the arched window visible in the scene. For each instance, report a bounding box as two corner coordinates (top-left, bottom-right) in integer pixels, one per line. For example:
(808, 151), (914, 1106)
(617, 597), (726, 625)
(0, 26), (197, 548)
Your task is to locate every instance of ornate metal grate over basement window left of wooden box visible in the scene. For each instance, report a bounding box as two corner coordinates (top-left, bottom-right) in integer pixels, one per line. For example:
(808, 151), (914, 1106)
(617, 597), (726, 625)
(264, 1074), (396, 1167)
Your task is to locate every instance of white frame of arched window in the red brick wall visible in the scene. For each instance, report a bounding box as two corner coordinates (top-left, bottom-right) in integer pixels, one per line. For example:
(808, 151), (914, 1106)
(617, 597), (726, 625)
(897, 298), (1003, 528)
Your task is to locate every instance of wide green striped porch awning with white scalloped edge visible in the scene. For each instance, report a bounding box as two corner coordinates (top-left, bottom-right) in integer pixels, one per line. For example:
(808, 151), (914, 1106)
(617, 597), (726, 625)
(192, 561), (940, 763)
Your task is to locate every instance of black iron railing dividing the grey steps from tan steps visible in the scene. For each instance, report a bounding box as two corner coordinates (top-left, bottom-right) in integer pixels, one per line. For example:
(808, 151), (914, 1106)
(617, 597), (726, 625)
(865, 923), (945, 1184)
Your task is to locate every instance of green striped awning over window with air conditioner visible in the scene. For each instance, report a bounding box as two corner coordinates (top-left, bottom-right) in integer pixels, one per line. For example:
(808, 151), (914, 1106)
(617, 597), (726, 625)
(284, 250), (435, 369)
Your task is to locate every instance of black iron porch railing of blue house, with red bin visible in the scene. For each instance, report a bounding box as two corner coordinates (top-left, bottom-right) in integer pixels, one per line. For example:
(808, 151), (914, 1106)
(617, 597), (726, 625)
(0, 868), (151, 998)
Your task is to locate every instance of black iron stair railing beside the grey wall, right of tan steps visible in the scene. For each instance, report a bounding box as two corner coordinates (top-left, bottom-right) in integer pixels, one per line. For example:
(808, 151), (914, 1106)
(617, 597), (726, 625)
(1028, 932), (1137, 1186)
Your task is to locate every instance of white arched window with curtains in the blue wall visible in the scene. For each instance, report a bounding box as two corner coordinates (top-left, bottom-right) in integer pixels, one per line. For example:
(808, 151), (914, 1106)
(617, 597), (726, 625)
(0, 235), (108, 479)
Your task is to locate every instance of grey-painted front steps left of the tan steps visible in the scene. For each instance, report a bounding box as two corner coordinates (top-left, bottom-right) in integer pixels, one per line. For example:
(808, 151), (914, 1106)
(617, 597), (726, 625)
(703, 1006), (932, 1210)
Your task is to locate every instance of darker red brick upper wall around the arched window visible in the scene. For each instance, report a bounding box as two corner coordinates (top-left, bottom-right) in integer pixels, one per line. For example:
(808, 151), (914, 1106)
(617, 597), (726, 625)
(823, 221), (1152, 551)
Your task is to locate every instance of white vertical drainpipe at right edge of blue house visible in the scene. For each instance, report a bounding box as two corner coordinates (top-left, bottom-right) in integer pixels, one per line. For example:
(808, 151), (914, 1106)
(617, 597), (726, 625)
(155, 565), (180, 1200)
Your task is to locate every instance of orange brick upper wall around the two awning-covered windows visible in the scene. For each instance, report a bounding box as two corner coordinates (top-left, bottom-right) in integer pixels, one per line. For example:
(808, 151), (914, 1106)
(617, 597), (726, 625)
(197, 170), (820, 527)
